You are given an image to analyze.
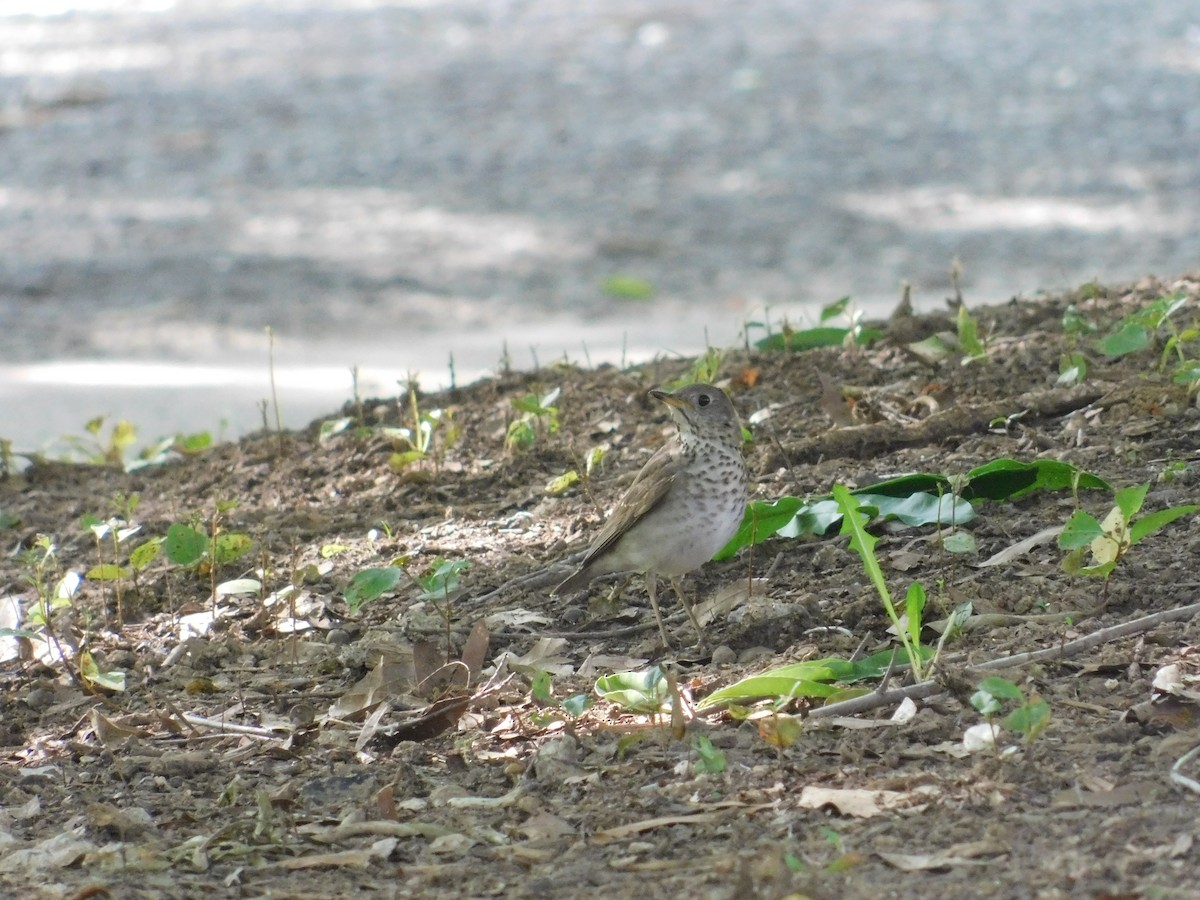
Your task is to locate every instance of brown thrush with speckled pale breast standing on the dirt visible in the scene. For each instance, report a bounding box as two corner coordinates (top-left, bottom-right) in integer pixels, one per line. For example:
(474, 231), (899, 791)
(552, 384), (746, 647)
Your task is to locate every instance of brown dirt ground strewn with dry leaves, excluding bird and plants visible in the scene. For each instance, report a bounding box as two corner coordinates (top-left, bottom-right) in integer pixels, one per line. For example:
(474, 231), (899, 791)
(0, 278), (1200, 898)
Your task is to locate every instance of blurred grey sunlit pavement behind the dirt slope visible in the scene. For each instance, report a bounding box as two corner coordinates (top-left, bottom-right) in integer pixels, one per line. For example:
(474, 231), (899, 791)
(0, 0), (1200, 450)
